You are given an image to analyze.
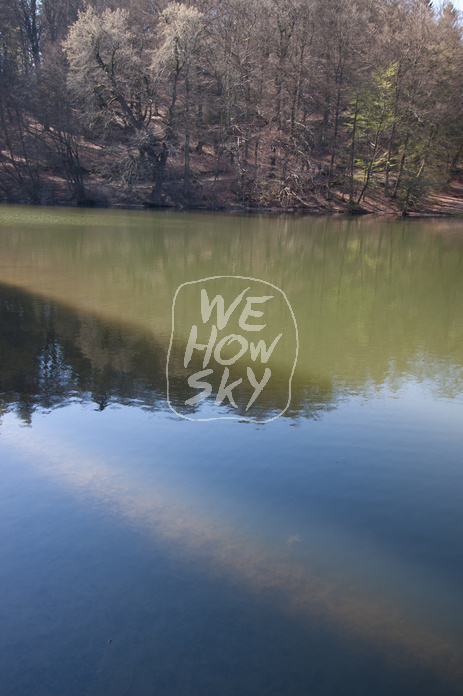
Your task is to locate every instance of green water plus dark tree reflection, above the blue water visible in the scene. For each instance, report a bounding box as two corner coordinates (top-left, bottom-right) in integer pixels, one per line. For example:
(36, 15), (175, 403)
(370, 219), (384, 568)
(0, 214), (463, 418)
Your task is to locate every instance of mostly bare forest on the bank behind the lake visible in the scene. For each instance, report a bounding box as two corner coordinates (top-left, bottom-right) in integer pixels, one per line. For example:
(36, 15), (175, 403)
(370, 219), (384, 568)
(0, 0), (463, 214)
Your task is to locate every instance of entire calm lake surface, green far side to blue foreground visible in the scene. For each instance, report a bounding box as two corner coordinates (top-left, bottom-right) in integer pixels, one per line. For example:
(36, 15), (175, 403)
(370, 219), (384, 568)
(0, 207), (463, 696)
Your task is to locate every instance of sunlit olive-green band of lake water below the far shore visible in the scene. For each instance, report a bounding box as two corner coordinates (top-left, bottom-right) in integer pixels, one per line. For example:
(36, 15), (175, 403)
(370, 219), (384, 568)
(0, 209), (463, 402)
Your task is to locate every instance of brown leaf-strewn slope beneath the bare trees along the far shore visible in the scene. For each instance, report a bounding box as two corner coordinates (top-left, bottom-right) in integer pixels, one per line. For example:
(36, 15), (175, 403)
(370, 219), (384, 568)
(4, 131), (463, 217)
